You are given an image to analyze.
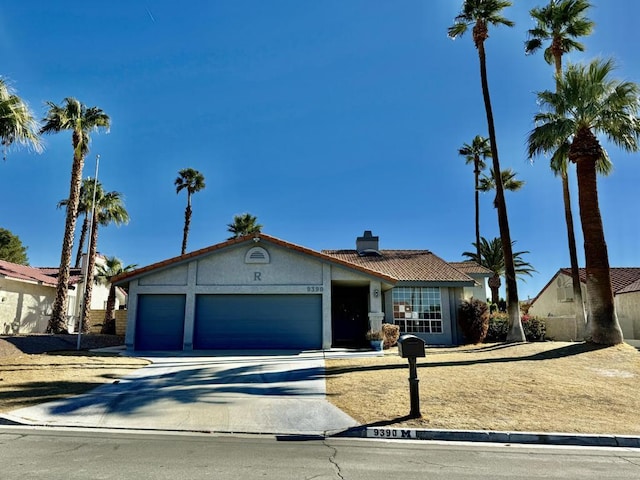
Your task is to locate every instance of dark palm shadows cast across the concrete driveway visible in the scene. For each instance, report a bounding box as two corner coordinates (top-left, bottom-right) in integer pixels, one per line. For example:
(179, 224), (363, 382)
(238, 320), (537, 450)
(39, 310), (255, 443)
(13, 365), (324, 415)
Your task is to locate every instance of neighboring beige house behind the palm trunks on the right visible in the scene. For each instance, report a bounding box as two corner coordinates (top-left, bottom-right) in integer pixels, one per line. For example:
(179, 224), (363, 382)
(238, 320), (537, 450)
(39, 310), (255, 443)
(529, 267), (640, 340)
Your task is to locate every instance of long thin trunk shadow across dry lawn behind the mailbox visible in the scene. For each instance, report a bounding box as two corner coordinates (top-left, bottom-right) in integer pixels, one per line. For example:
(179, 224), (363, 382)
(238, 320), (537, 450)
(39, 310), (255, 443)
(326, 343), (609, 377)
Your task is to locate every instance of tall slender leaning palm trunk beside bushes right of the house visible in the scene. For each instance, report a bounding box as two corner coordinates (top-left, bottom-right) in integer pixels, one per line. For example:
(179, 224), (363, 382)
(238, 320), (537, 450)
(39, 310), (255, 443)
(476, 42), (526, 343)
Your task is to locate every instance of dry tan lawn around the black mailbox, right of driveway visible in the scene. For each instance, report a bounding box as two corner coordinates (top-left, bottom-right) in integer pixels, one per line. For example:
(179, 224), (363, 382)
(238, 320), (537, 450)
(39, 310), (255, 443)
(326, 342), (640, 435)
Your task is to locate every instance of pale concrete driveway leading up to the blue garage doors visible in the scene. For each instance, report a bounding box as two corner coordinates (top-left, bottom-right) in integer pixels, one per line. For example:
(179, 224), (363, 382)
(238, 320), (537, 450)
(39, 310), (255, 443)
(3, 352), (358, 435)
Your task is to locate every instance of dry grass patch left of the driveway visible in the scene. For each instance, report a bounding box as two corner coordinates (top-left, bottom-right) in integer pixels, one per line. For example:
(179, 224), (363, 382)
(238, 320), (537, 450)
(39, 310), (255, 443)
(0, 352), (149, 412)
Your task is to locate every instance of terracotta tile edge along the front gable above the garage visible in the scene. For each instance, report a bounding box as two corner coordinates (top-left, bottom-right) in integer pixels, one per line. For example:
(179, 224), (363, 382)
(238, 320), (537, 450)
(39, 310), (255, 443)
(112, 233), (398, 284)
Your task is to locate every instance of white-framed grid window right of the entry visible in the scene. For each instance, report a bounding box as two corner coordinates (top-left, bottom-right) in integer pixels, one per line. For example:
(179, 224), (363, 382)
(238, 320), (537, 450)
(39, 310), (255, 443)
(391, 287), (443, 334)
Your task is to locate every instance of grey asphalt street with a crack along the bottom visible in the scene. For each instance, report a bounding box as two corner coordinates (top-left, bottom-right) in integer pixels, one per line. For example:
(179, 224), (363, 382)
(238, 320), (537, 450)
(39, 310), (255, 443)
(0, 427), (640, 480)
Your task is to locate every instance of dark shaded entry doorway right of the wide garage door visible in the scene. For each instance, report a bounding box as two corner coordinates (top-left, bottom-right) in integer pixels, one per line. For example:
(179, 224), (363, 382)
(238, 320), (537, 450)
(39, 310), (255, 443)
(331, 286), (369, 347)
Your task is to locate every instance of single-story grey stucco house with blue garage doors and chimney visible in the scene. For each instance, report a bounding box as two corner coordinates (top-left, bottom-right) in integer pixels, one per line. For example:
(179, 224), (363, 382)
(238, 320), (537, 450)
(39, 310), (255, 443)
(113, 231), (490, 350)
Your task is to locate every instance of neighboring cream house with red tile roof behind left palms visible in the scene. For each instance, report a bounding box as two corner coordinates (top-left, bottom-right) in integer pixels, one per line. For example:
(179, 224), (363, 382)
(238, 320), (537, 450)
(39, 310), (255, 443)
(0, 258), (126, 335)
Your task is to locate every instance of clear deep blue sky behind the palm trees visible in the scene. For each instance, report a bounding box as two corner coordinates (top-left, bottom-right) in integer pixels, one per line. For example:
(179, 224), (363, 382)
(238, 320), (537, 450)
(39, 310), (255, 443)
(0, 0), (640, 298)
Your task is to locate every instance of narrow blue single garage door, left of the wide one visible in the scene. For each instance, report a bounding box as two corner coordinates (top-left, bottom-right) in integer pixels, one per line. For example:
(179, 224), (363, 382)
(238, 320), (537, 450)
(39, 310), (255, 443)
(135, 294), (186, 350)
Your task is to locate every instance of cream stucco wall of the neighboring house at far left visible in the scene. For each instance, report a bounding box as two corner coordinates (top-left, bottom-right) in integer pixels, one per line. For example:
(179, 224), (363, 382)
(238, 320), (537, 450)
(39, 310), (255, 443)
(0, 278), (55, 335)
